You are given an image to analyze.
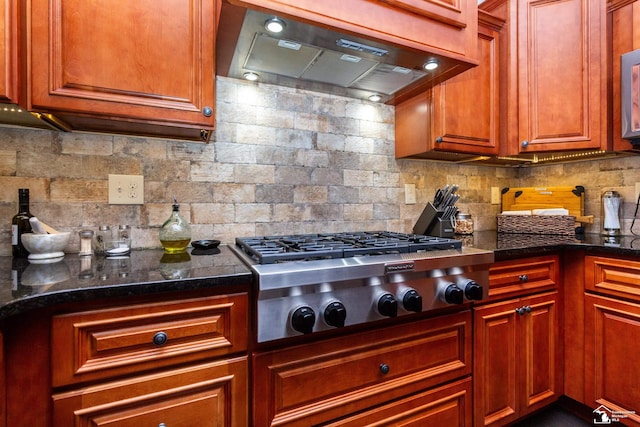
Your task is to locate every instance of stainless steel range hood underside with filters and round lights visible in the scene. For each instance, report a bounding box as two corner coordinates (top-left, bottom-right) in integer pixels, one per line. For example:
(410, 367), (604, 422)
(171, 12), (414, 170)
(216, 3), (473, 104)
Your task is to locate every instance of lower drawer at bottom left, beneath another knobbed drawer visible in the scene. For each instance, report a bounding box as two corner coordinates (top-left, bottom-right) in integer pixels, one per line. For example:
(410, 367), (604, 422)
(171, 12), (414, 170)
(53, 356), (249, 427)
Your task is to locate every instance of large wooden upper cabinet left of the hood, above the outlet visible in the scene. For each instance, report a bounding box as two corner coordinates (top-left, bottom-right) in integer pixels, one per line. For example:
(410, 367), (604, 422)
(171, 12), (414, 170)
(28, 0), (216, 140)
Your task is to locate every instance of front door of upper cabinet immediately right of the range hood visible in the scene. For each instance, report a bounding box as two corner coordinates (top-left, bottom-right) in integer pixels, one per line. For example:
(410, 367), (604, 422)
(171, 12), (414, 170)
(432, 11), (503, 155)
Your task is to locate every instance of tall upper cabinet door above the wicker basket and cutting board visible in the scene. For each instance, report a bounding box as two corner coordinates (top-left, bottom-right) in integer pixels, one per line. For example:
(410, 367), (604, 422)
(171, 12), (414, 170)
(509, 0), (607, 154)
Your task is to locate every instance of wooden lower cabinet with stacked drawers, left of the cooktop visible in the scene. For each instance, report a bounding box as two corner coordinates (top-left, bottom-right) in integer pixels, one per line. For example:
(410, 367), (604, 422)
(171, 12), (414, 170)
(51, 292), (249, 427)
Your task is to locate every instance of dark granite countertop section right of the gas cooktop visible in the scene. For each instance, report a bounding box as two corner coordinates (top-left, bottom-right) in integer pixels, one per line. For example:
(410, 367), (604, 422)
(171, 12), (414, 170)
(468, 231), (640, 261)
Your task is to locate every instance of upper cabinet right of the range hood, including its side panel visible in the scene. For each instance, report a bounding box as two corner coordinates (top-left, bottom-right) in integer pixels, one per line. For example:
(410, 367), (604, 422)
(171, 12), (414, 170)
(396, 10), (504, 158)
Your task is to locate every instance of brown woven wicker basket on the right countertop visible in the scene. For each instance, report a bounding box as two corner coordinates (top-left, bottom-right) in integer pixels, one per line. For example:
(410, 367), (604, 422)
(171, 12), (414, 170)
(497, 215), (576, 236)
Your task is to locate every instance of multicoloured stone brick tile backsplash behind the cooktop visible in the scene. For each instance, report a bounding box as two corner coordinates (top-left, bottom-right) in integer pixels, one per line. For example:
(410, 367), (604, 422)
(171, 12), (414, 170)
(0, 77), (640, 255)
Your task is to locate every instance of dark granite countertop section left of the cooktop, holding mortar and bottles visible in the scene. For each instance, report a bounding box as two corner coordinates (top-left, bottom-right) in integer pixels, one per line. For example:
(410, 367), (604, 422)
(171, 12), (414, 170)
(0, 246), (251, 319)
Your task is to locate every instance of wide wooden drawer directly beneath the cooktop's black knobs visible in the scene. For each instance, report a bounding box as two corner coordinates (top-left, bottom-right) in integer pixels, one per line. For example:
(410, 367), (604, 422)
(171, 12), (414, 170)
(253, 311), (471, 427)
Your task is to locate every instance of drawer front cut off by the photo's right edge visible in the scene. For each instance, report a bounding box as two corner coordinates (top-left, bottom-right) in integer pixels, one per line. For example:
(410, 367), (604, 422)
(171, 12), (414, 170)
(584, 256), (640, 301)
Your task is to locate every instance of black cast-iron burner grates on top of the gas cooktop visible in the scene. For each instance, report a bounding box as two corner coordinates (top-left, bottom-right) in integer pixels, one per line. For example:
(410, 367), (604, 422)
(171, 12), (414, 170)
(236, 231), (462, 264)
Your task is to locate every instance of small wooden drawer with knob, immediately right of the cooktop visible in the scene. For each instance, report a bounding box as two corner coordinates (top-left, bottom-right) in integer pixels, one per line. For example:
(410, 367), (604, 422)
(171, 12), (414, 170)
(489, 255), (559, 300)
